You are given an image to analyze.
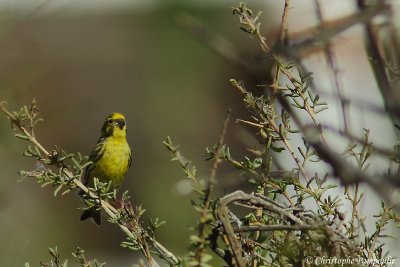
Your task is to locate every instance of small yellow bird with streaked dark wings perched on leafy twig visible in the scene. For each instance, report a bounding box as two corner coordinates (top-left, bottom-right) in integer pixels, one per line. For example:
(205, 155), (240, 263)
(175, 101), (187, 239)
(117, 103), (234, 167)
(80, 112), (132, 225)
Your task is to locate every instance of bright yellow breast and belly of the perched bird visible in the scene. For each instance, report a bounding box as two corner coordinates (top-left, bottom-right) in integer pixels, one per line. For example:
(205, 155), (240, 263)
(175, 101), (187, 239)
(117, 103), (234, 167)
(89, 137), (131, 187)
